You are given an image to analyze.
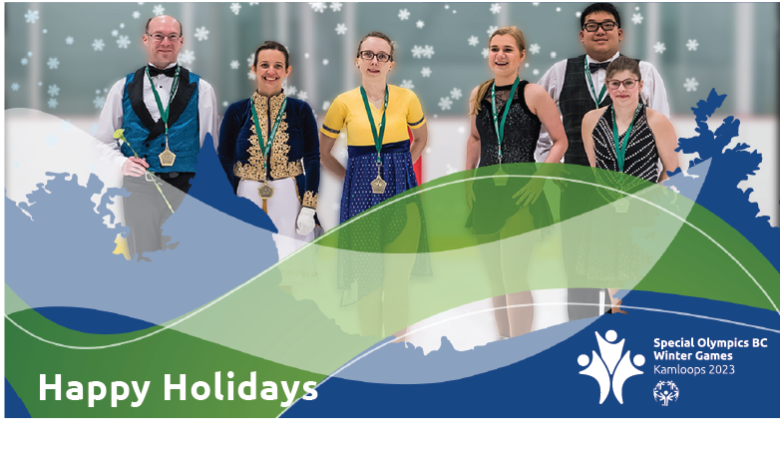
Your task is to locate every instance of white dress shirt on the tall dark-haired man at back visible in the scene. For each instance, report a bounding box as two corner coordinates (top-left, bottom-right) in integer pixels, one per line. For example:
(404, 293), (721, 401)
(536, 52), (669, 162)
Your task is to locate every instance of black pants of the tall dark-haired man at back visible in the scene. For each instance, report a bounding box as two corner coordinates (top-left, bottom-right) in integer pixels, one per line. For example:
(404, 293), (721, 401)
(561, 154), (610, 321)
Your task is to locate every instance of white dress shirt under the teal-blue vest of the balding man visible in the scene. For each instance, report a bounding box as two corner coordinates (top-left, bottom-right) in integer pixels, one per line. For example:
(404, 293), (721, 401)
(95, 63), (219, 169)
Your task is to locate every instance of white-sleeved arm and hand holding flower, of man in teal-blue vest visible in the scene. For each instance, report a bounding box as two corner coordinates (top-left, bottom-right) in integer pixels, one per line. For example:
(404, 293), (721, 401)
(95, 79), (149, 177)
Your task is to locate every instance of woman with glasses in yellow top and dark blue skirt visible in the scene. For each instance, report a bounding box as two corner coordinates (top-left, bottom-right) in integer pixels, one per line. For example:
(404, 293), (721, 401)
(320, 32), (430, 338)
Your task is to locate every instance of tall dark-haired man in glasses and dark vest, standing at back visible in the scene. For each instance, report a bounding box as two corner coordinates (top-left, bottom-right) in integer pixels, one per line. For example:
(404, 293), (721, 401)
(536, 3), (669, 320)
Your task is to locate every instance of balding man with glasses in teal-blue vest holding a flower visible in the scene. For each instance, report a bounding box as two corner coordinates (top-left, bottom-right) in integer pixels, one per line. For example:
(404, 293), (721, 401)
(96, 16), (218, 260)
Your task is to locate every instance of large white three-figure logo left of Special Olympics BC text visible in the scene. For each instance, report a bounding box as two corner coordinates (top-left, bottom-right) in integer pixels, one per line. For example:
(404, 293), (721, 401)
(577, 331), (645, 405)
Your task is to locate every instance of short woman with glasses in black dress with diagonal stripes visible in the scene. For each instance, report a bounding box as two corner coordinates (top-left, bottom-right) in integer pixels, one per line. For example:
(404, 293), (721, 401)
(578, 57), (678, 314)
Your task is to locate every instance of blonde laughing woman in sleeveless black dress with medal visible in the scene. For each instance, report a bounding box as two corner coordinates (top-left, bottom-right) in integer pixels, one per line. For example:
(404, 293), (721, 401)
(466, 27), (568, 338)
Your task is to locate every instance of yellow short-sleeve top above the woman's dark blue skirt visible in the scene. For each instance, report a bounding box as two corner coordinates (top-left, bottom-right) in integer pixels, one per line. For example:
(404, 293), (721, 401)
(320, 85), (425, 147)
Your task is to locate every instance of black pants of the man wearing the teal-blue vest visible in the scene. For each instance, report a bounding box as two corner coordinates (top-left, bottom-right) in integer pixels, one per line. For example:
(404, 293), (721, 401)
(124, 173), (195, 259)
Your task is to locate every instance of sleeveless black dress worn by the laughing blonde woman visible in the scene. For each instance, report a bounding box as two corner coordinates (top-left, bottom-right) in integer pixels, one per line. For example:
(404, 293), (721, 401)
(466, 81), (553, 235)
